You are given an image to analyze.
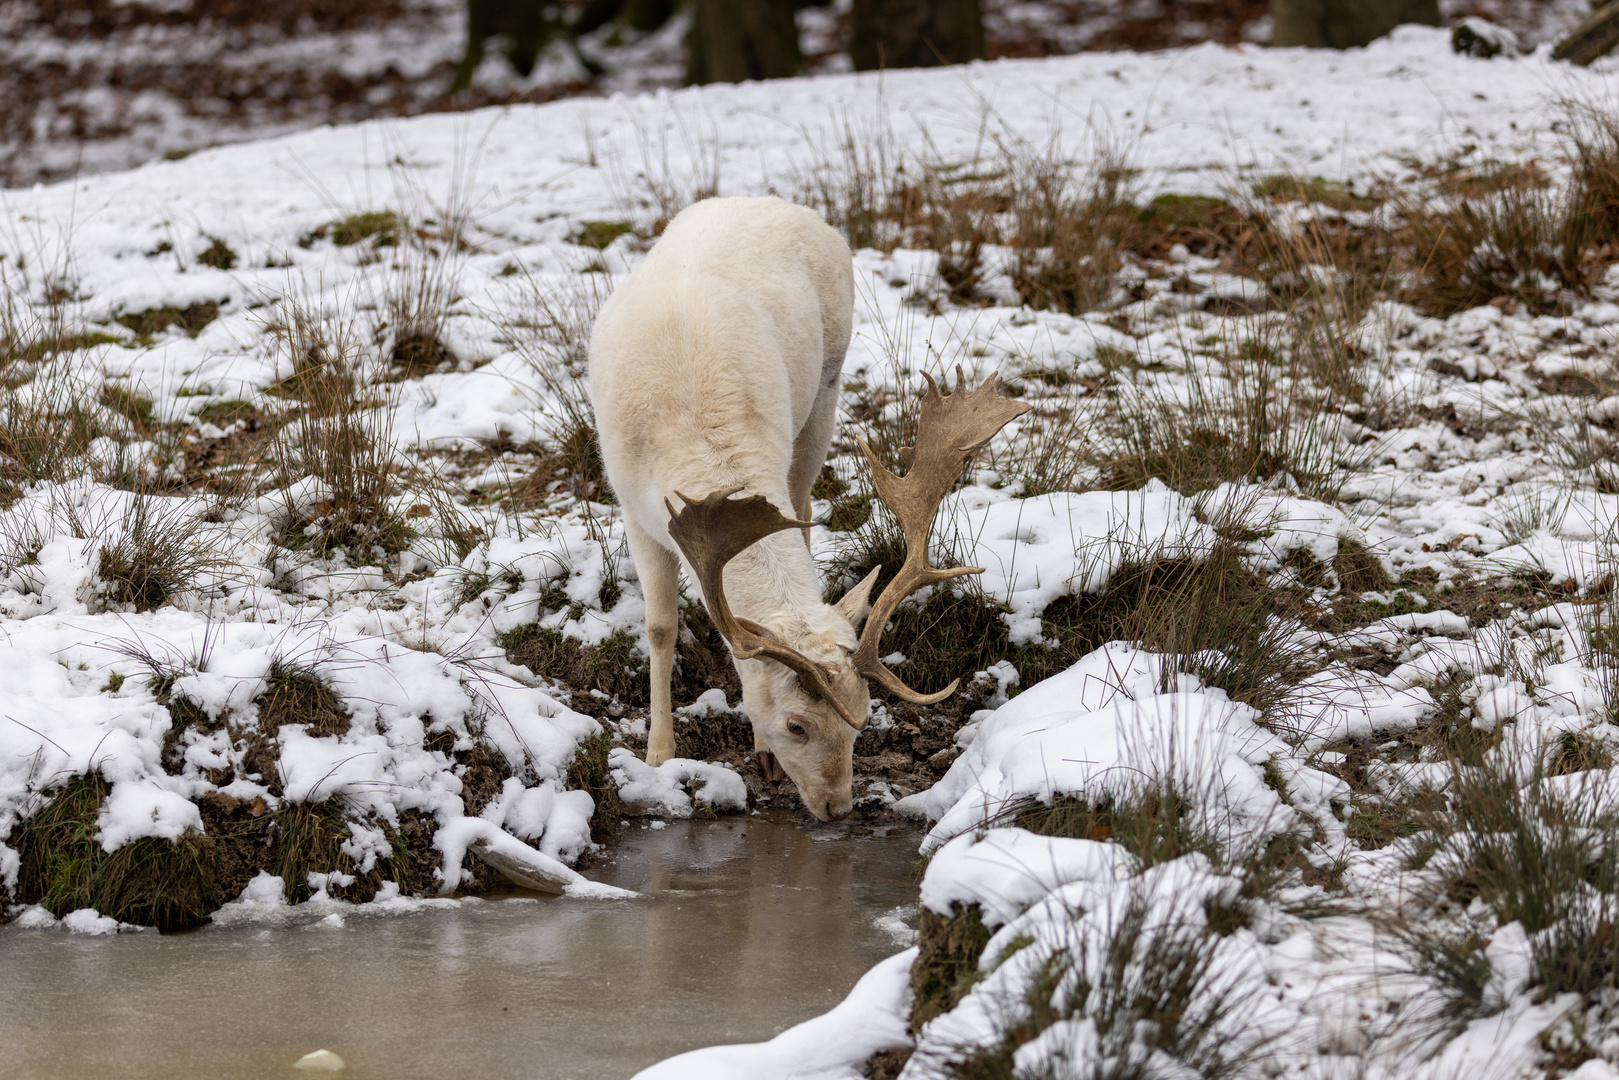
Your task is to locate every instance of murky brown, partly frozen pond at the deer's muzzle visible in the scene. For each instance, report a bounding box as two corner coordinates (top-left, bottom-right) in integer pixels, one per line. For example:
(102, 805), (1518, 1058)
(0, 818), (920, 1080)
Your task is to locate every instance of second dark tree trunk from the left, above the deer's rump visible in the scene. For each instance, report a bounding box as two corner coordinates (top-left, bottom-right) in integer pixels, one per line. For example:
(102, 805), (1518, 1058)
(686, 0), (803, 84)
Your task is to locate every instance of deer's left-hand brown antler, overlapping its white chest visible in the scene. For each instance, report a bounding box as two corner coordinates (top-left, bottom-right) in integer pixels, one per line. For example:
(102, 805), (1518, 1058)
(664, 487), (863, 729)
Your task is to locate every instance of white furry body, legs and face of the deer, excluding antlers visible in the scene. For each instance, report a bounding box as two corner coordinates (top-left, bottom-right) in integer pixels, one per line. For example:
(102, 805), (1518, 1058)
(591, 198), (869, 818)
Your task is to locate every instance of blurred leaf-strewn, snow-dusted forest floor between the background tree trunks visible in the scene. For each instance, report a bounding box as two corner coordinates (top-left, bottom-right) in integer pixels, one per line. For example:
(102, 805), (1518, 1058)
(0, 0), (1588, 186)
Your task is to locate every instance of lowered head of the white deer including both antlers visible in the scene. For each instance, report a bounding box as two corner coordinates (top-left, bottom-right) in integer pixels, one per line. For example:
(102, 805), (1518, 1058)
(669, 369), (1028, 821)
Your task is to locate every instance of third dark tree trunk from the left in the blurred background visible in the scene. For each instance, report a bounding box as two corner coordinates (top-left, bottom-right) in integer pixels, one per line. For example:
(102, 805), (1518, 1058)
(848, 0), (984, 71)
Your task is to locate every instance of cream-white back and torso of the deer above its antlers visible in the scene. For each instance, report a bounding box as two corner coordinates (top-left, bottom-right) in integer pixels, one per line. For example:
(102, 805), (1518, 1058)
(591, 199), (853, 537)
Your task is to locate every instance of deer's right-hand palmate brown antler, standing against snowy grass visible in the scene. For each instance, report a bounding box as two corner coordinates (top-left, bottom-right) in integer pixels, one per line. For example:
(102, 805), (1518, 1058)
(855, 368), (1028, 704)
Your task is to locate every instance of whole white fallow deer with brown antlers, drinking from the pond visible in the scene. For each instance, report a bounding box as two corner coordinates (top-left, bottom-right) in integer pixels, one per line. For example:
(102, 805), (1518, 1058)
(591, 198), (1028, 821)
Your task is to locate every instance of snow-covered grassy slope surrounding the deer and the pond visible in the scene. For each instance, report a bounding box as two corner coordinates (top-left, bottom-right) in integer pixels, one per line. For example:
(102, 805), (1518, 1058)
(9, 28), (1619, 1080)
